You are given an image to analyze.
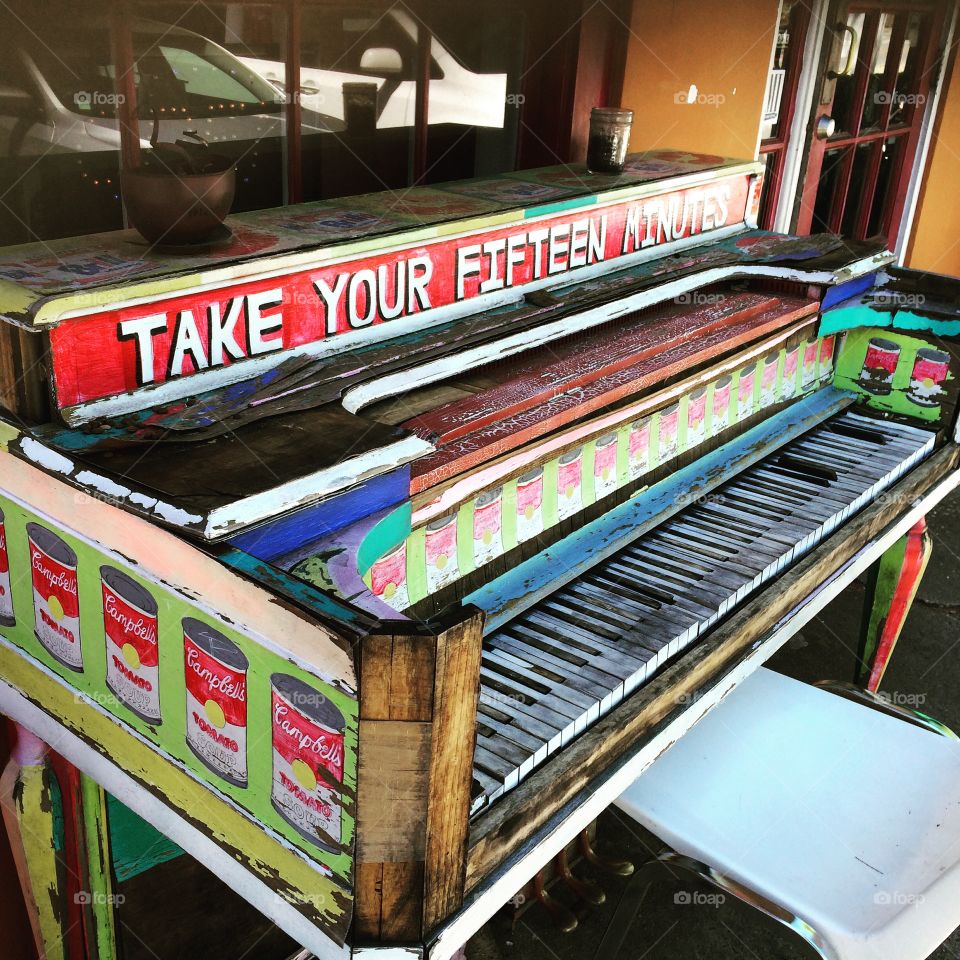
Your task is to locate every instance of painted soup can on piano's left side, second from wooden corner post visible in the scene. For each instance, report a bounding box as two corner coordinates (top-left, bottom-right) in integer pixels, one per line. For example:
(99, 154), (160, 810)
(183, 617), (248, 787)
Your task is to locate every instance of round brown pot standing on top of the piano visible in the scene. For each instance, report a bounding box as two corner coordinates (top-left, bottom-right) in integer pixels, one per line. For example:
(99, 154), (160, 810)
(120, 156), (237, 245)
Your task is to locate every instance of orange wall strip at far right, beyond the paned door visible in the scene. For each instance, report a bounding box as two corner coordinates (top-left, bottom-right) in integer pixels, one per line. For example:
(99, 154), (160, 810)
(906, 48), (960, 276)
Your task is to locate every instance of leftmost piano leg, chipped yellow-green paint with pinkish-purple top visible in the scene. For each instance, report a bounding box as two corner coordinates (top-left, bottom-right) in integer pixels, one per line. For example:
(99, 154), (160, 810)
(0, 724), (70, 960)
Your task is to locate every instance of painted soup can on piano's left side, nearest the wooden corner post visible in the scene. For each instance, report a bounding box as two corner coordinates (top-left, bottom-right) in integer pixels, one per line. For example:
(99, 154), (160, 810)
(270, 673), (345, 852)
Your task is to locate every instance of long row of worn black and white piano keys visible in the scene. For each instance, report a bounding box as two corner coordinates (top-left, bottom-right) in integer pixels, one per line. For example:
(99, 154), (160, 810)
(471, 411), (934, 812)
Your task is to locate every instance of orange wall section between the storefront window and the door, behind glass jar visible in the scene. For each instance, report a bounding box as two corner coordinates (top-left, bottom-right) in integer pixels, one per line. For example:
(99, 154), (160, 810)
(621, 0), (778, 158)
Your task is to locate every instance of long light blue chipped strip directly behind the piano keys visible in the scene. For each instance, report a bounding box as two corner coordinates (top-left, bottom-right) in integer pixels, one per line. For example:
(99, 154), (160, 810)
(463, 387), (856, 633)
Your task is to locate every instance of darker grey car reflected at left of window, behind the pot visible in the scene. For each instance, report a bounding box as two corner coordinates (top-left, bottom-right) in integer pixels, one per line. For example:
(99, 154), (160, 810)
(0, 20), (343, 159)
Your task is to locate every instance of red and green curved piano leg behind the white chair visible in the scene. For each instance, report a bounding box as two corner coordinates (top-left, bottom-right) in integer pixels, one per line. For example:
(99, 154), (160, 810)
(857, 518), (932, 693)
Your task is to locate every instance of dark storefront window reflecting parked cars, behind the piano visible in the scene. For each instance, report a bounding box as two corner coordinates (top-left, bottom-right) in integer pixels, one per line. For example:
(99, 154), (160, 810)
(0, 0), (575, 245)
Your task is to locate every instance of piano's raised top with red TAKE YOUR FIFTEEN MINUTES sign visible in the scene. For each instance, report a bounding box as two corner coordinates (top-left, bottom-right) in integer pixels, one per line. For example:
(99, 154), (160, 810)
(7, 153), (762, 424)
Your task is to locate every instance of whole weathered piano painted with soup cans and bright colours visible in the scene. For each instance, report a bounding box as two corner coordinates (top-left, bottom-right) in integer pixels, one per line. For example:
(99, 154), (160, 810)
(0, 151), (960, 960)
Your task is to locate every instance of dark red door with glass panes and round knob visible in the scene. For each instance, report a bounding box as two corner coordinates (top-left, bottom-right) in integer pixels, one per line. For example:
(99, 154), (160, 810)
(796, 0), (946, 246)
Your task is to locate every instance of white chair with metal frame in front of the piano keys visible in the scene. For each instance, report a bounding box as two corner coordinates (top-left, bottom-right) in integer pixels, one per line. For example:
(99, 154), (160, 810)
(596, 668), (960, 960)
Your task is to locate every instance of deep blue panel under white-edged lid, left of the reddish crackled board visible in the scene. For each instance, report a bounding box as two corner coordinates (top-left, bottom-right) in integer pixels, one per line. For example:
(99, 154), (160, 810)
(227, 464), (410, 560)
